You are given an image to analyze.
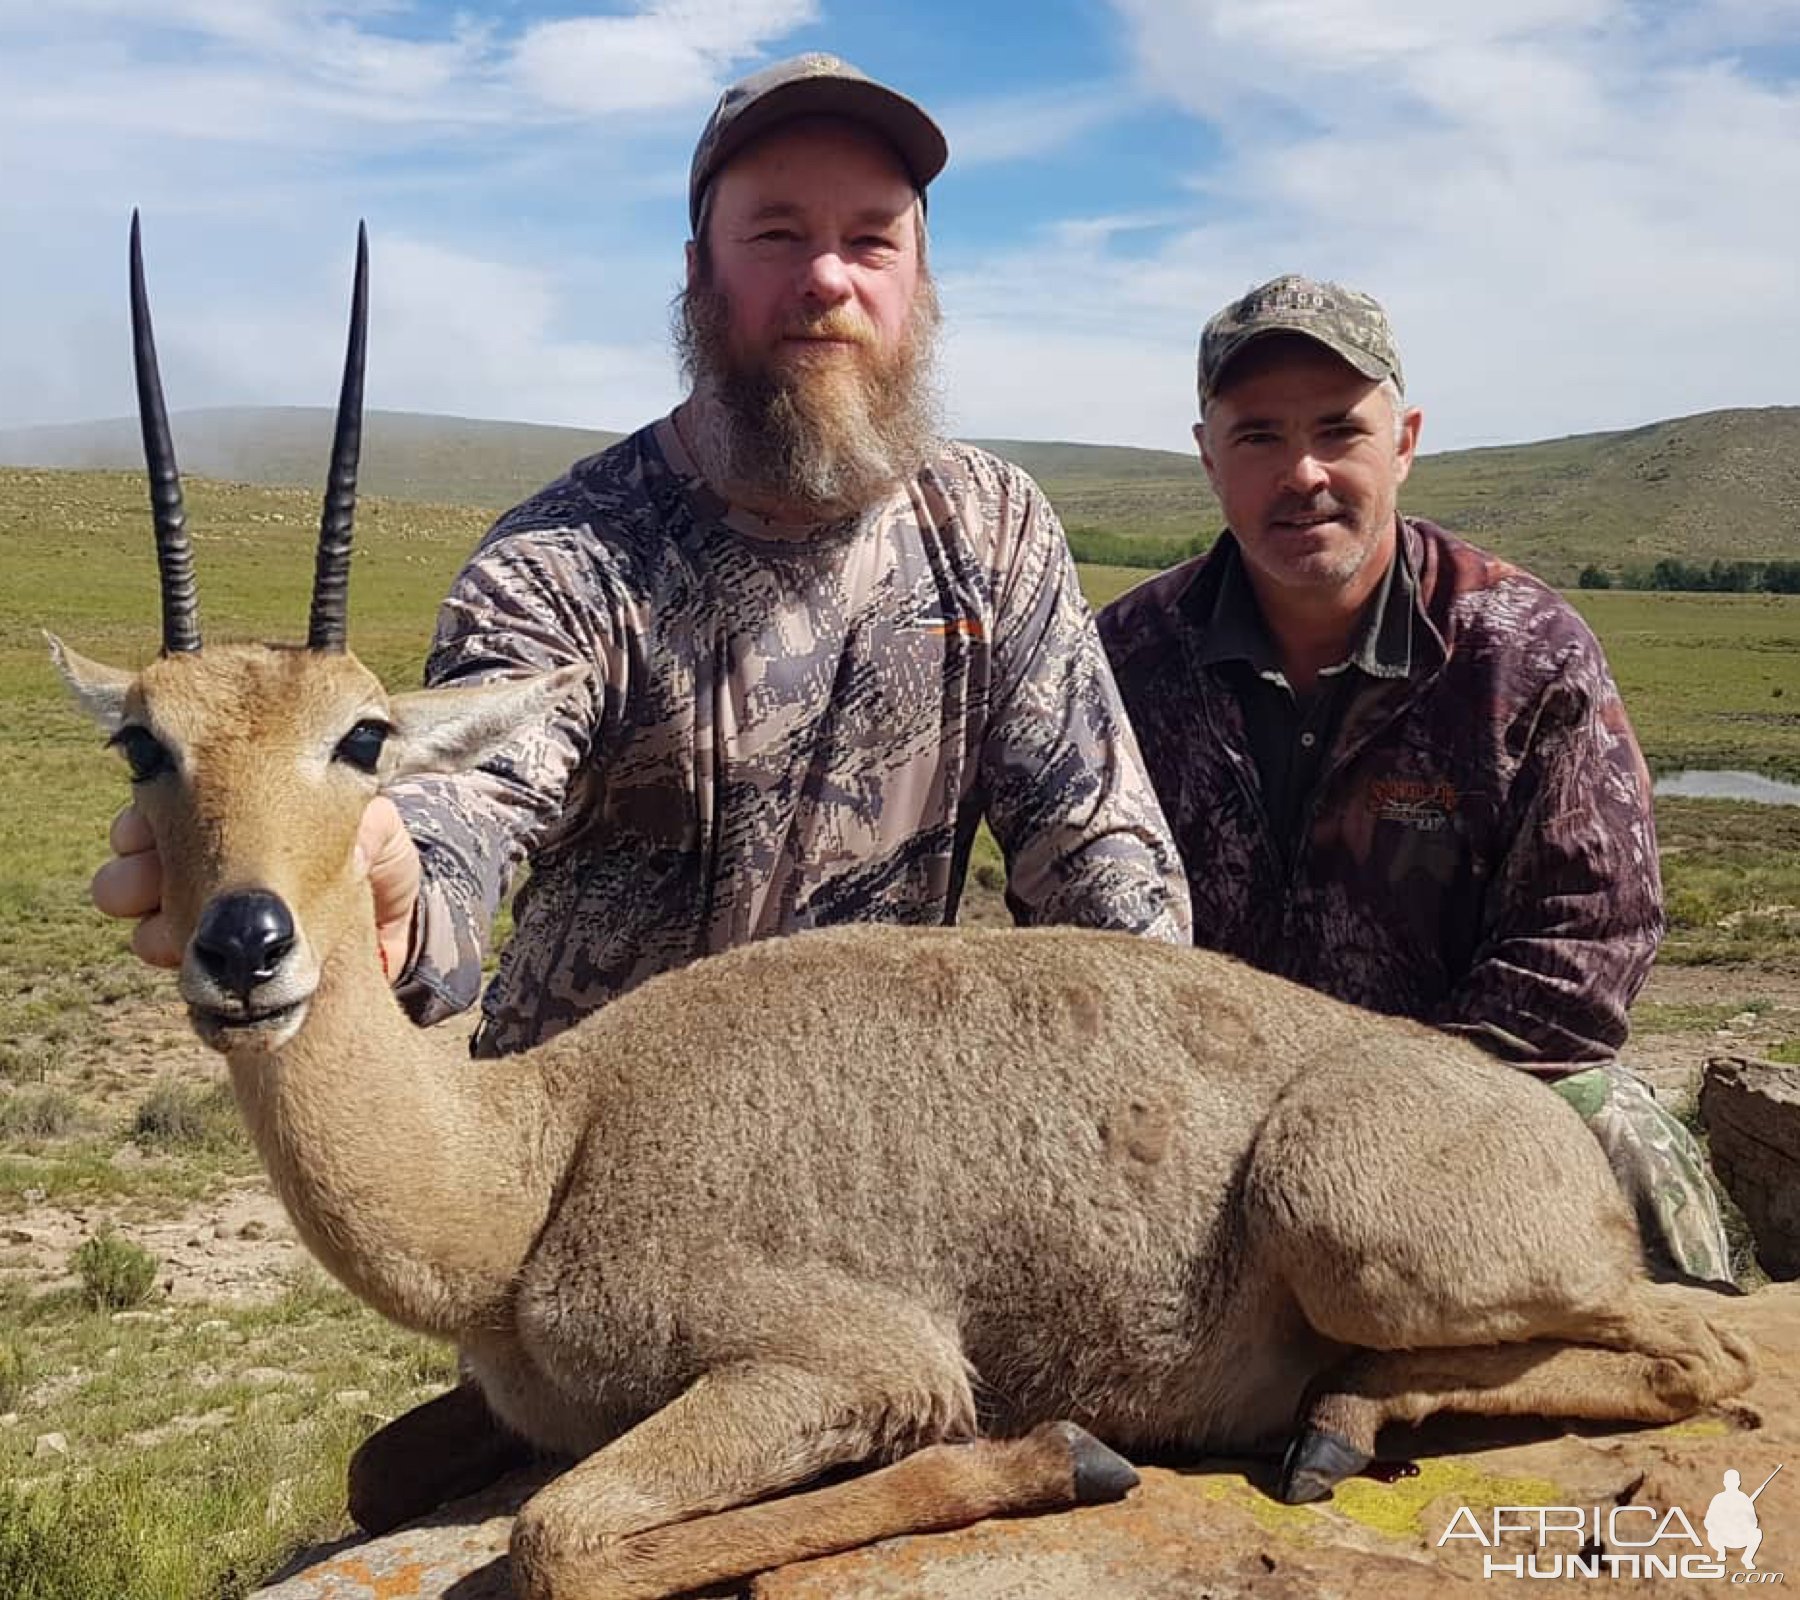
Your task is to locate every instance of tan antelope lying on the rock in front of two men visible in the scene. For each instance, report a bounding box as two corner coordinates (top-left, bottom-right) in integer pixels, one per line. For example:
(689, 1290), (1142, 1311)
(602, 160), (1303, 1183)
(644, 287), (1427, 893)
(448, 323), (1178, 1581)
(54, 221), (1750, 1596)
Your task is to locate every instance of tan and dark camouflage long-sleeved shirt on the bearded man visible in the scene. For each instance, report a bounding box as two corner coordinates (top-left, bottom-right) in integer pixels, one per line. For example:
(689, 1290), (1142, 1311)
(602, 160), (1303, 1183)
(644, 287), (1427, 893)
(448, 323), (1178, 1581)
(392, 418), (1190, 1055)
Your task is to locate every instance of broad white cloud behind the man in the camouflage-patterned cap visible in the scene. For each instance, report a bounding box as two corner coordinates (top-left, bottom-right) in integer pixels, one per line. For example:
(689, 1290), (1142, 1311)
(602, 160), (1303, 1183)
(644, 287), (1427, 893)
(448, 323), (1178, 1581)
(947, 0), (1800, 448)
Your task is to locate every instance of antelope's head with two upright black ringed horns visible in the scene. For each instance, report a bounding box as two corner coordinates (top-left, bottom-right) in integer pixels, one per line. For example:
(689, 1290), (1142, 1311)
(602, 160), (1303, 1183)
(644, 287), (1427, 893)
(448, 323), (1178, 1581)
(50, 214), (587, 1051)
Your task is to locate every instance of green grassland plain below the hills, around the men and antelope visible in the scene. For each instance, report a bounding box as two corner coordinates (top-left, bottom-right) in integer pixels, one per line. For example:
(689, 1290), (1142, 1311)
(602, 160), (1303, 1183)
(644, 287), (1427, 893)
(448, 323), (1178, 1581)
(0, 452), (1800, 1600)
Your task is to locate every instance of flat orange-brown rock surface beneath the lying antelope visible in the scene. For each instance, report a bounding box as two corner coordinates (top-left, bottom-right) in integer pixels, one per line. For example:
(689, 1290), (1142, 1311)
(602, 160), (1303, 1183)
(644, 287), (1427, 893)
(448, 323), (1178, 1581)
(257, 1283), (1800, 1600)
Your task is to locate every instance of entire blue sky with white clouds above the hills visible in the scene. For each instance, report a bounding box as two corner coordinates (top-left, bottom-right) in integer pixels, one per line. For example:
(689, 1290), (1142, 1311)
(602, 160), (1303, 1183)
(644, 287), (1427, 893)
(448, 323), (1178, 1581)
(0, 0), (1800, 450)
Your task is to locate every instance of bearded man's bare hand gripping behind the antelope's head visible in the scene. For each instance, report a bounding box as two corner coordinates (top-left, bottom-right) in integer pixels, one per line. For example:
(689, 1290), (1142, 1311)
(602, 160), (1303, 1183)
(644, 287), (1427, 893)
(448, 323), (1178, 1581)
(92, 796), (419, 975)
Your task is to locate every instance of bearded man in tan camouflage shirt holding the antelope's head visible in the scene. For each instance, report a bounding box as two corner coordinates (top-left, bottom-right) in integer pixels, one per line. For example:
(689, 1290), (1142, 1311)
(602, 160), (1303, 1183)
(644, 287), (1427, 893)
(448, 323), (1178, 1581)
(94, 56), (1190, 1055)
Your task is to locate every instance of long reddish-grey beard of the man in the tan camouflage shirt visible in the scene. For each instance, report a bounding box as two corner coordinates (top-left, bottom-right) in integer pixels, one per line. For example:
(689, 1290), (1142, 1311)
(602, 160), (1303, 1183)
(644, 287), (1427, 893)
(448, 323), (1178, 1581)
(675, 277), (940, 520)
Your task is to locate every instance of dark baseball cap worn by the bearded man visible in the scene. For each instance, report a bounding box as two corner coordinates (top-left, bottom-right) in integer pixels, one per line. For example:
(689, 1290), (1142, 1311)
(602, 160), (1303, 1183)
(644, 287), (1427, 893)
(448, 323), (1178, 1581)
(688, 50), (950, 229)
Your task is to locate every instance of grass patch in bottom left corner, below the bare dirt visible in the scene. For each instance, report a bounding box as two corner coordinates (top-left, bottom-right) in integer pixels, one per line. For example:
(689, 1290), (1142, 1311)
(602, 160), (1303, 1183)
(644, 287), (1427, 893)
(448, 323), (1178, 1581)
(0, 1269), (455, 1600)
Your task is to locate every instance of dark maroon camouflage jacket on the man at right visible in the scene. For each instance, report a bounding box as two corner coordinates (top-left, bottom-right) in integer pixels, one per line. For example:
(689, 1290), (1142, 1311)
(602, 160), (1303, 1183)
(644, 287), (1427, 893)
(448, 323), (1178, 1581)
(1100, 518), (1663, 1076)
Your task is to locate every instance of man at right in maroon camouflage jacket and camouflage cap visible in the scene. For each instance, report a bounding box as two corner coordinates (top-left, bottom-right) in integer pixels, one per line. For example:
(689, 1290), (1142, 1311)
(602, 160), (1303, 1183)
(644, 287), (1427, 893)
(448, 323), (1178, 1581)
(1100, 275), (1730, 1281)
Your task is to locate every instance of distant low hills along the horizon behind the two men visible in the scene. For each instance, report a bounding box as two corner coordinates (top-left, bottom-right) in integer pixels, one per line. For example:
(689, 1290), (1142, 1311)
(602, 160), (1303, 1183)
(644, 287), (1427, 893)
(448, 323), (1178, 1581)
(10, 407), (1800, 583)
